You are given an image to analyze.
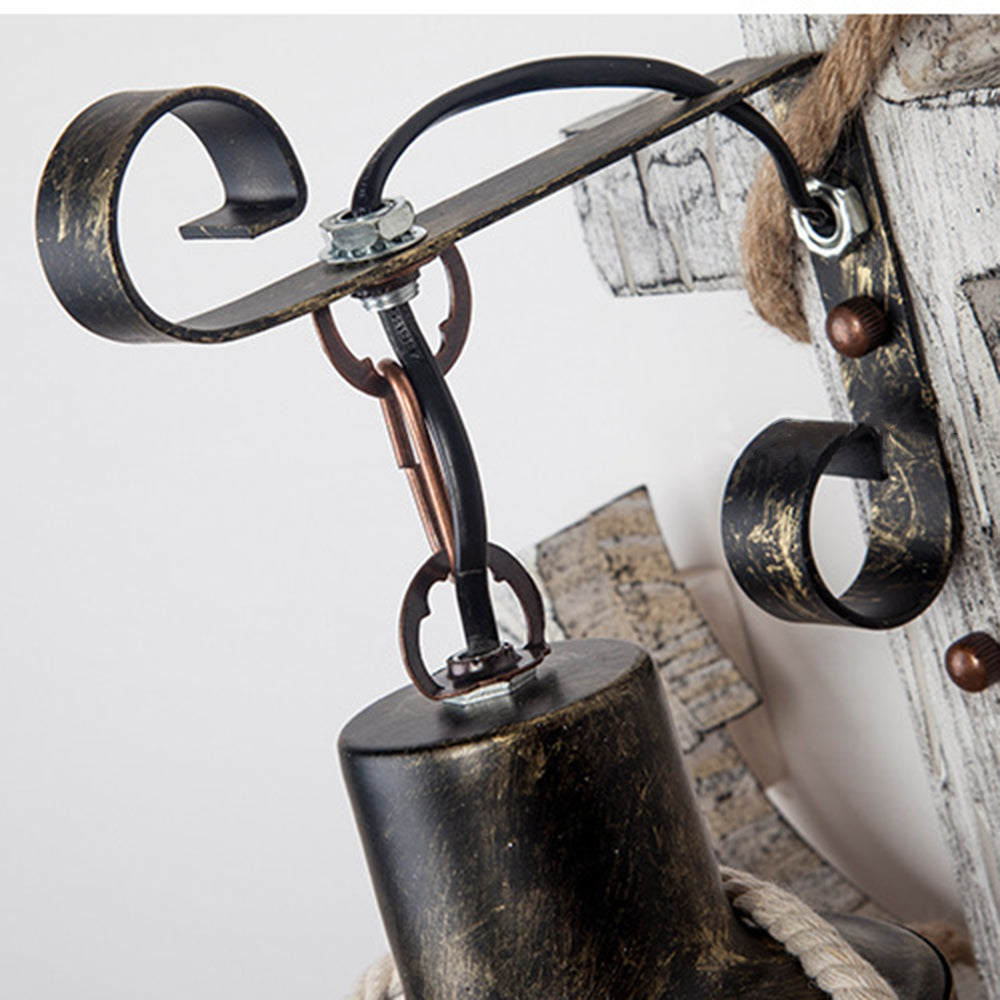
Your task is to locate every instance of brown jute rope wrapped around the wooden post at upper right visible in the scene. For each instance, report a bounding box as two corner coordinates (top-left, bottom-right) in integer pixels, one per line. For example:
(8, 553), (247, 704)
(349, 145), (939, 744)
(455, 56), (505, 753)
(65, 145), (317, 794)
(742, 14), (912, 341)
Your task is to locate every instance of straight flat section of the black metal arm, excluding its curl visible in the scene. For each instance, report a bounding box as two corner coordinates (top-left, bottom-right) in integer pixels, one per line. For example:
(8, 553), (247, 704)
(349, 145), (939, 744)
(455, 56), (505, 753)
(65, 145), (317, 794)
(184, 53), (818, 342)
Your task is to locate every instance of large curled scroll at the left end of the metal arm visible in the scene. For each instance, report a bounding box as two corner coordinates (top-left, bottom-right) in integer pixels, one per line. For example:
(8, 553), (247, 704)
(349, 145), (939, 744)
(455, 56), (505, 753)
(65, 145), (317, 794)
(35, 87), (306, 341)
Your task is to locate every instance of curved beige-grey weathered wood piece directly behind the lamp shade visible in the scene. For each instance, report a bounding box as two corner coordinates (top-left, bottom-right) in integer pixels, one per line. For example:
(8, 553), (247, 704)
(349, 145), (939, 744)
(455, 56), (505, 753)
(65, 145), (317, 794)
(500, 488), (882, 916)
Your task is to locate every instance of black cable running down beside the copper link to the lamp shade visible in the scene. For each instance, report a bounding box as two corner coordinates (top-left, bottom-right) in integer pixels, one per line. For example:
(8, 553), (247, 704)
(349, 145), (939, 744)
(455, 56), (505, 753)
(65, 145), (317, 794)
(379, 304), (500, 657)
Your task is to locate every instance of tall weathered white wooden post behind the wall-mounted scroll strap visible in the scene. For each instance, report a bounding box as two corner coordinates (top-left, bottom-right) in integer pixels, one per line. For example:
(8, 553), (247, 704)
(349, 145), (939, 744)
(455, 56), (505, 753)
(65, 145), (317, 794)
(744, 18), (1000, 1000)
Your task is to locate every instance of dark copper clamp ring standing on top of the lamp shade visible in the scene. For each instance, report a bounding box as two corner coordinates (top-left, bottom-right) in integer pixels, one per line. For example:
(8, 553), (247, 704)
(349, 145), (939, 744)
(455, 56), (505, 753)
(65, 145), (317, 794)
(399, 543), (549, 701)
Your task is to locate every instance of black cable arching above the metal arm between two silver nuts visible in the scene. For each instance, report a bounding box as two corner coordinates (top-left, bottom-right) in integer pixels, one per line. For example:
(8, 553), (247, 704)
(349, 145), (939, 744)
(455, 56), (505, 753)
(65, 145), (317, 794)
(351, 56), (832, 231)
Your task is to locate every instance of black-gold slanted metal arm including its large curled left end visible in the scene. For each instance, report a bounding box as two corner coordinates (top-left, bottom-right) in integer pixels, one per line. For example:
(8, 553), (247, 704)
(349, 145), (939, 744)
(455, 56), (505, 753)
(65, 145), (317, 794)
(36, 55), (816, 343)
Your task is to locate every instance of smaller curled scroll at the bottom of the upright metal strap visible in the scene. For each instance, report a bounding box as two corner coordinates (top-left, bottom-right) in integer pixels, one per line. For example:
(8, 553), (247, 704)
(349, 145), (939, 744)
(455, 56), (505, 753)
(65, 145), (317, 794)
(722, 420), (954, 629)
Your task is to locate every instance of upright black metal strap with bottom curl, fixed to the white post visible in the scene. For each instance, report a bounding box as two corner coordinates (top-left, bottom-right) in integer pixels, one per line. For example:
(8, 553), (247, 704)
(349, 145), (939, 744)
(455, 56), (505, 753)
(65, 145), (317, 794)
(722, 122), (958, 629)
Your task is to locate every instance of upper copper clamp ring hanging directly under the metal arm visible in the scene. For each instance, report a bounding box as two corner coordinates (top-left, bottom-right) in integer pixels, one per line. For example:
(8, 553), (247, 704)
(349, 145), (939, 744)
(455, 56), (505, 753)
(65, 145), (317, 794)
(313, 246), (472, 396)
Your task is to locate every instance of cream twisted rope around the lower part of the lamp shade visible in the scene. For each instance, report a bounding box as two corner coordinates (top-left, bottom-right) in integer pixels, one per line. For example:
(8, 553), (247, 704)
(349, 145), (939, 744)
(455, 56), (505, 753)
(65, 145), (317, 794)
(351, 868), (898, 1000)
